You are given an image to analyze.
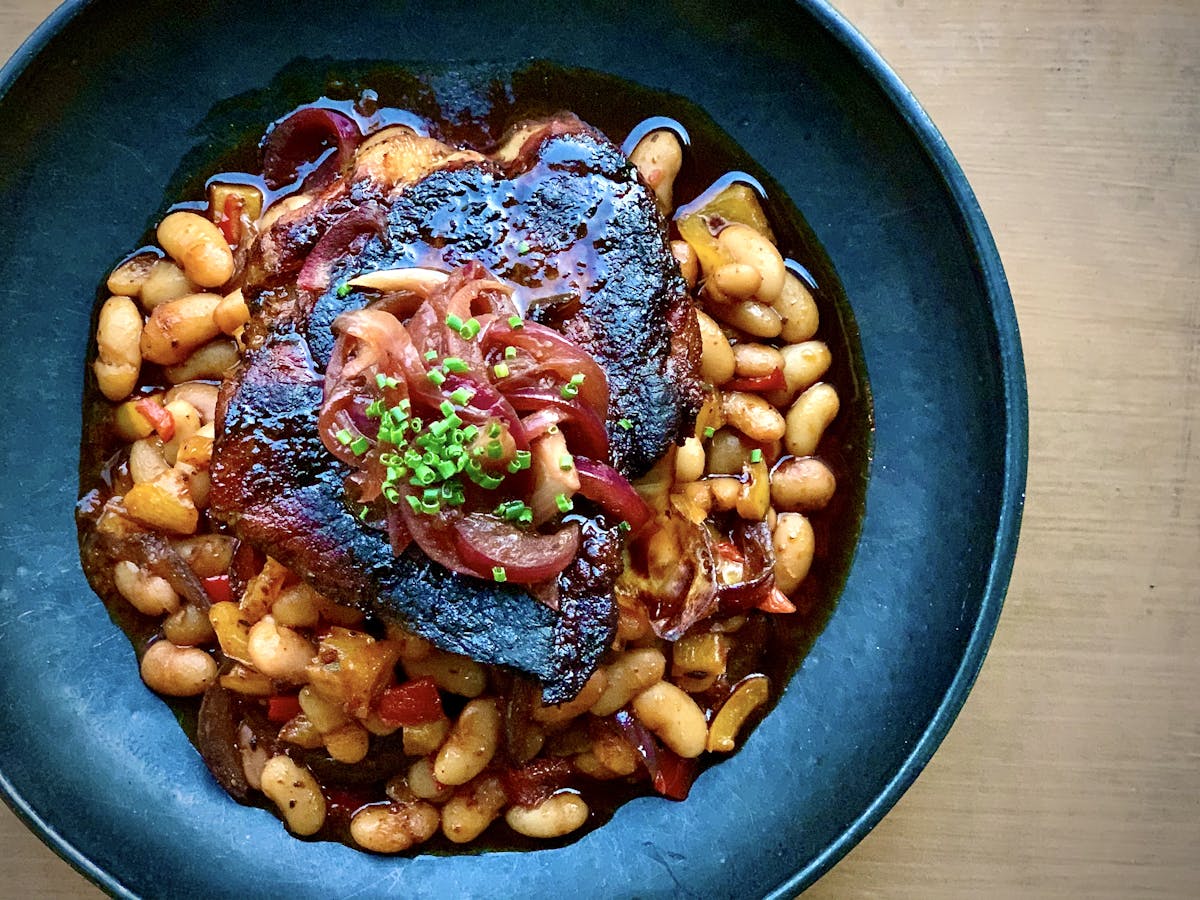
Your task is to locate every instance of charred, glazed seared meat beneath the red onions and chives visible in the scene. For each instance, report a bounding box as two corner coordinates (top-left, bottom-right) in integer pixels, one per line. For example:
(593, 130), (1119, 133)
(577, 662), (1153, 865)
(211, 119), (701, 703)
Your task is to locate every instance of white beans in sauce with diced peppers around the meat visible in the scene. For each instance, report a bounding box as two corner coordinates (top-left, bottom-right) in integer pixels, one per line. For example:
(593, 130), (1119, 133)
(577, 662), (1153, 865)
(87, 116), (839, 853)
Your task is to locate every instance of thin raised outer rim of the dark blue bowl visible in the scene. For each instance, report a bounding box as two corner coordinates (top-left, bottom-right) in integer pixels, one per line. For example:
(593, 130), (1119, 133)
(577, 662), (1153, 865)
(0, 0), (1028, 900)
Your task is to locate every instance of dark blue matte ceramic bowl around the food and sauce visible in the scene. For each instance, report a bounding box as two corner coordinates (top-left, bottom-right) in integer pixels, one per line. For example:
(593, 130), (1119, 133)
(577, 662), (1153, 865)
(0, 0), (1026, 900)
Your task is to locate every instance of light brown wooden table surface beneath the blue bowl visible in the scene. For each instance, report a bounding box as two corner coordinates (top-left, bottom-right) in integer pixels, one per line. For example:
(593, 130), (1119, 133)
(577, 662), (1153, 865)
(0, 0), (1200, 899)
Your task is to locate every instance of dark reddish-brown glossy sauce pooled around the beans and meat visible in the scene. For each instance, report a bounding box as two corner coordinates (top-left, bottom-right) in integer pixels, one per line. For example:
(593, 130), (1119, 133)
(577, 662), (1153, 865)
(79, 61), (872, 853)
